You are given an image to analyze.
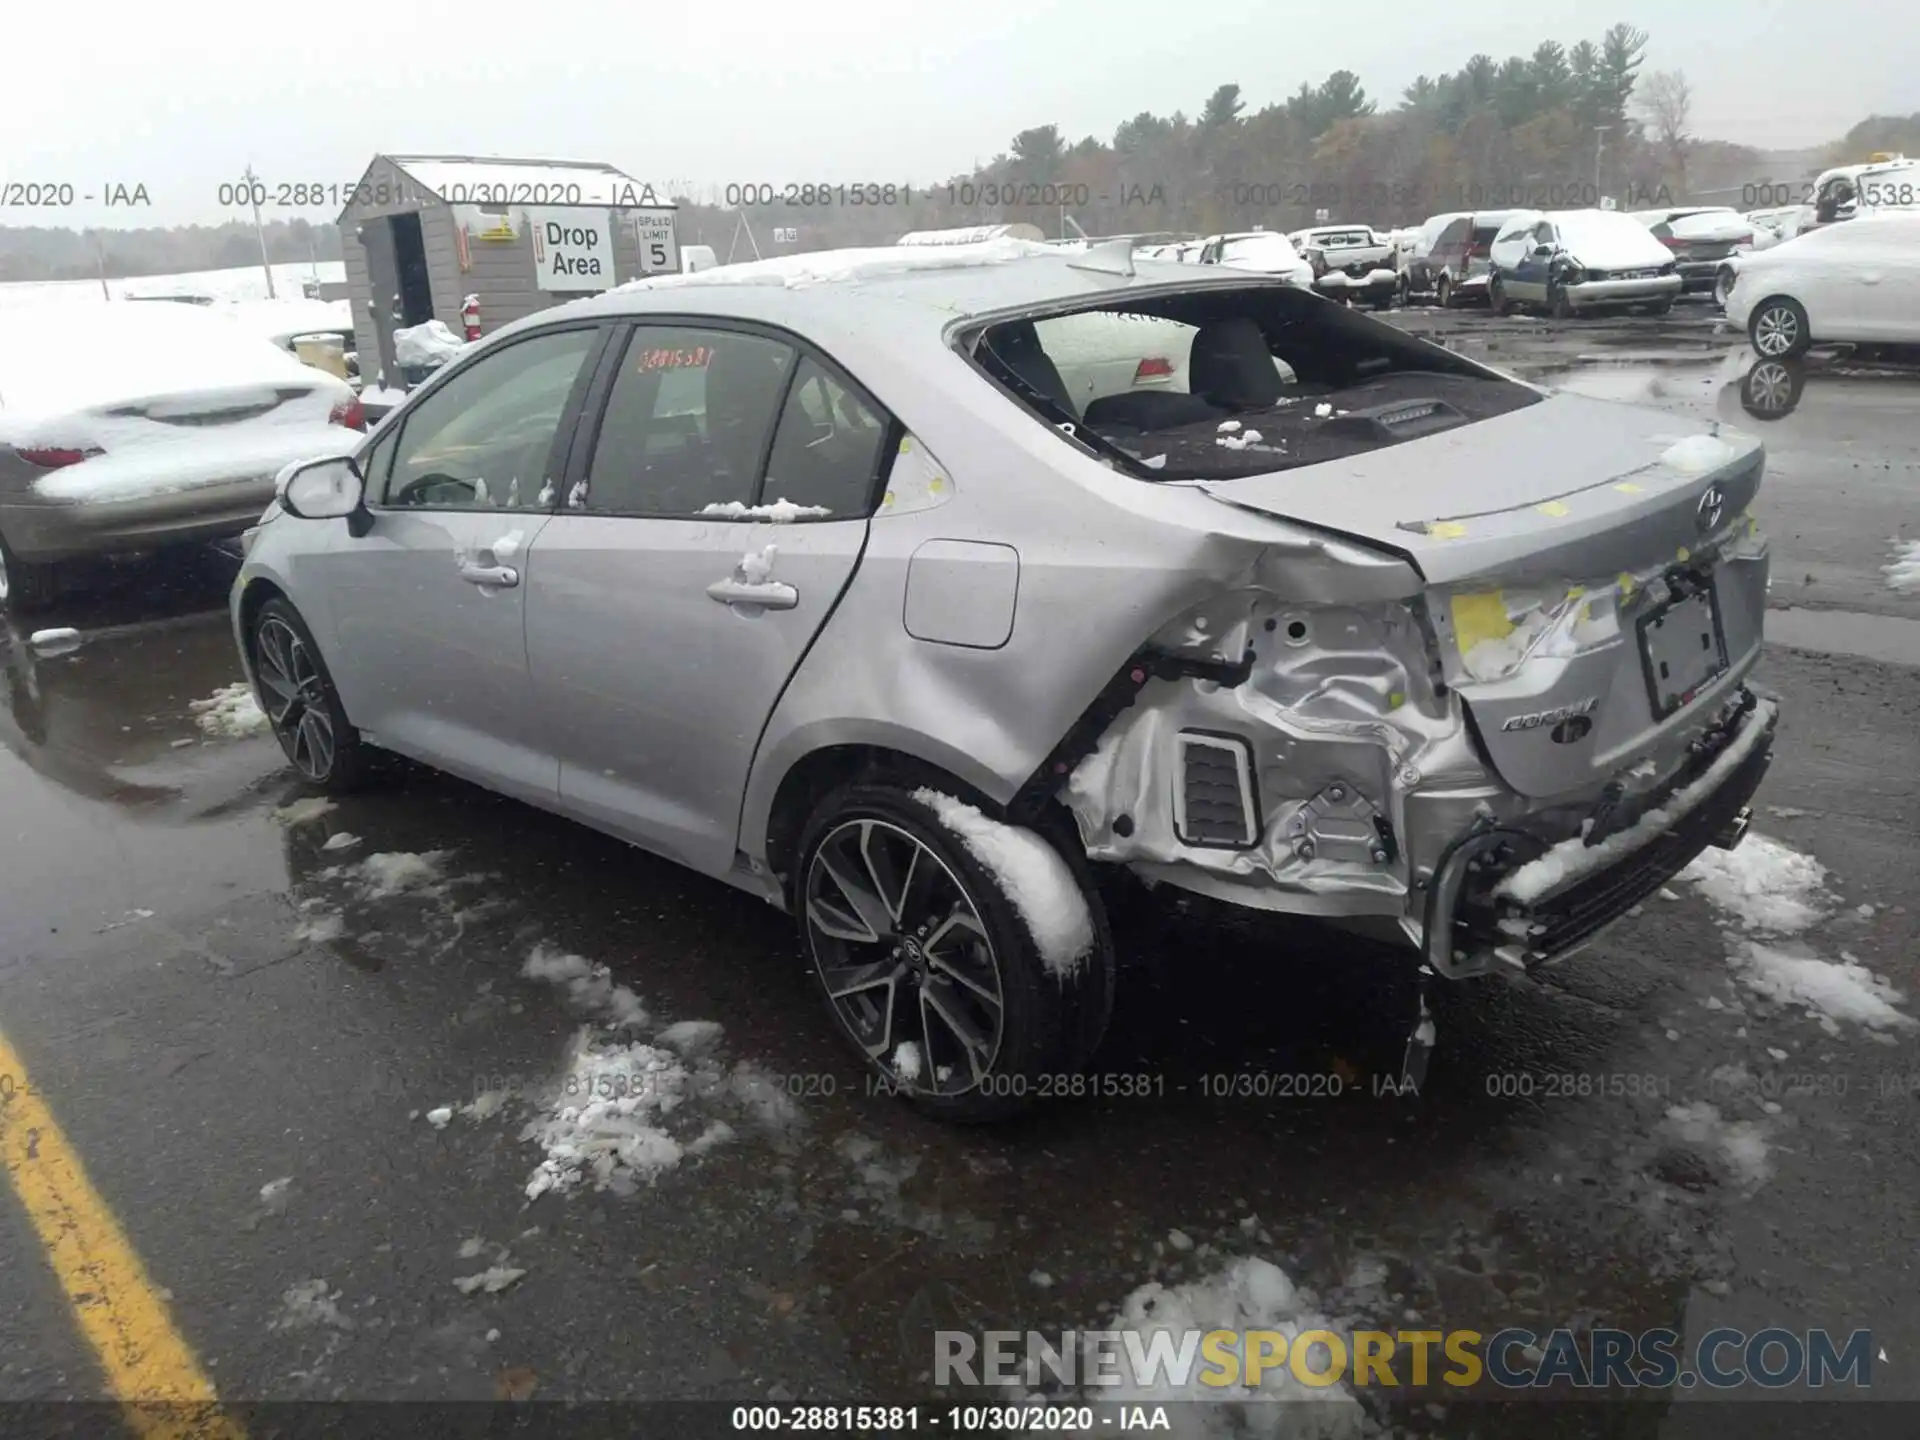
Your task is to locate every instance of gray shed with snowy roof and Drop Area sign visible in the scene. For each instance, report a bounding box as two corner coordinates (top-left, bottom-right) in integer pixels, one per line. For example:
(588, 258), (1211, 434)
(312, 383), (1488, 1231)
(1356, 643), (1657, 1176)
(340, 156), (680, 390)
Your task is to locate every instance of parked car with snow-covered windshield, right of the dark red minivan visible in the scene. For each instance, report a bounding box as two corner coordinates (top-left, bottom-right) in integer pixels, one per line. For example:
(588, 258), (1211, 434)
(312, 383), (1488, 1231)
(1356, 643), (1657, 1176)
(1488, 209), (1680, 319)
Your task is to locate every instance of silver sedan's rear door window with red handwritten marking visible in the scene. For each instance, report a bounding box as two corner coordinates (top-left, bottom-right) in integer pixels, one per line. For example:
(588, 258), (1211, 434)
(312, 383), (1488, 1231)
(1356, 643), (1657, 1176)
(566, 324), (795, 516)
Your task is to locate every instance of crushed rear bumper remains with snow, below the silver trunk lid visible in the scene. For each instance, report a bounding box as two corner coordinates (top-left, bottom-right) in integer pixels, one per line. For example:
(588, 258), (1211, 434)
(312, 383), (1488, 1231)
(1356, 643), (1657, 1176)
(1423, 687), (1780, 979)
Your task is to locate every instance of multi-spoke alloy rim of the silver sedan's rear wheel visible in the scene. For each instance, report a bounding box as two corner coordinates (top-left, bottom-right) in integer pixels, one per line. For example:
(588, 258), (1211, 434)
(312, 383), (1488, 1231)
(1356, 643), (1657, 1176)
(803, 818), (1006, 1096)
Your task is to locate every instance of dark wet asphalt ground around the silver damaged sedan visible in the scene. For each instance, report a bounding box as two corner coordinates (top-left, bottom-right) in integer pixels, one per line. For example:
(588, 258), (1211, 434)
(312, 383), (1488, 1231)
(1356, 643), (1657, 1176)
(0, 307), (1920, 1436)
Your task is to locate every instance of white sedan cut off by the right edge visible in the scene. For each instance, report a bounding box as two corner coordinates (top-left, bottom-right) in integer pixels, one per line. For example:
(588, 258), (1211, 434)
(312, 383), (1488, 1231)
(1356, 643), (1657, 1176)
(1726, 211), (1920, 359)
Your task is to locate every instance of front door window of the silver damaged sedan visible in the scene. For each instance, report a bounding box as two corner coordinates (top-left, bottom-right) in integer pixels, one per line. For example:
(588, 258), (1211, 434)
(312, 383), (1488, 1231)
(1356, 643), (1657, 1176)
(382, 328), (599, 511)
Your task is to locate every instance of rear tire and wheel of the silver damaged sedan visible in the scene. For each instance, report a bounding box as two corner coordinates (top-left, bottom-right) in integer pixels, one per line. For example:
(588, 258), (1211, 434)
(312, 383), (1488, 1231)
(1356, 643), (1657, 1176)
(789, 780), (1114, 1123)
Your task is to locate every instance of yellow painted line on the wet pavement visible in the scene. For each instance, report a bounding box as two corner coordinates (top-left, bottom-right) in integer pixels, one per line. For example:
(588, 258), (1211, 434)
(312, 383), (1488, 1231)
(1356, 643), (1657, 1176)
(0, 1033), (246, 1440)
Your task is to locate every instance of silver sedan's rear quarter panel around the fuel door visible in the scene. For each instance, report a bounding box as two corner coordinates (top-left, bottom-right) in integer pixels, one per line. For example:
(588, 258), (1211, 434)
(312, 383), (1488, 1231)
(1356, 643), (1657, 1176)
(741, 334), (1419, 879)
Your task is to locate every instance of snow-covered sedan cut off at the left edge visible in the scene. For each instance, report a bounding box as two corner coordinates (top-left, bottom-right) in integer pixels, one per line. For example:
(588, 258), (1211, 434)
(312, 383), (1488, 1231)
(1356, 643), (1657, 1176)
(0, 303), (365, 612)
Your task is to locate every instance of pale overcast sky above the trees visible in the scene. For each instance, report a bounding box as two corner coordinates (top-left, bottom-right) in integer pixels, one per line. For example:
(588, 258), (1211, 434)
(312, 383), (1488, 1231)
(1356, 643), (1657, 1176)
(0, 0), (1920, 227)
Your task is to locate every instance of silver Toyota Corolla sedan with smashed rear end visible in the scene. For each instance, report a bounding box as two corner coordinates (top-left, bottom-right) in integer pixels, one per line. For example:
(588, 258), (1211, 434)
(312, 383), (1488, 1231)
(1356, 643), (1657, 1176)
(232, 240), (1776, 1119)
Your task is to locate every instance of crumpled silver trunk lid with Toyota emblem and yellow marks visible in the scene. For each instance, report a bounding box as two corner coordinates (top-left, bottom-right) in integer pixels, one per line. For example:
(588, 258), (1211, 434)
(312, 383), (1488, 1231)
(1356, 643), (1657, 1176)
(1198, 396), (1766, 797)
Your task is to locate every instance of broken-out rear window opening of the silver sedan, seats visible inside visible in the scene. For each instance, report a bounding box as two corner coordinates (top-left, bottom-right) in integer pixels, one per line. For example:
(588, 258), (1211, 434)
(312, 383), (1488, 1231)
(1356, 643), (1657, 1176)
(962, 286), (1540, 480)
